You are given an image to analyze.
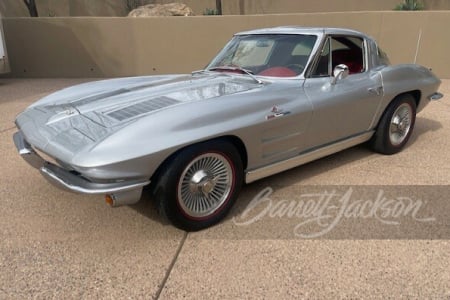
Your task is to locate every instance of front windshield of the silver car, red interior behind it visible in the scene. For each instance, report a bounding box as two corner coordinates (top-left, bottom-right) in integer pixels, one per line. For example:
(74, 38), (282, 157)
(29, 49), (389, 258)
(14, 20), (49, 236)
(207, 34), (317, 77)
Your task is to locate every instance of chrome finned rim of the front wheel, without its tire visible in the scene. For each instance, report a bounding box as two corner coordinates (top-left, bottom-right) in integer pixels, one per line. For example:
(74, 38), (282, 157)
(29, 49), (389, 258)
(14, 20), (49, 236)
(177, 153), (235, 219)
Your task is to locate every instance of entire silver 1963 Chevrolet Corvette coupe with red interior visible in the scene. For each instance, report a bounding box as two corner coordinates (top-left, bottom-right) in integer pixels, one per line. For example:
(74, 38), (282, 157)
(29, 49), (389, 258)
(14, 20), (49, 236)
(14, 27), (442, 230)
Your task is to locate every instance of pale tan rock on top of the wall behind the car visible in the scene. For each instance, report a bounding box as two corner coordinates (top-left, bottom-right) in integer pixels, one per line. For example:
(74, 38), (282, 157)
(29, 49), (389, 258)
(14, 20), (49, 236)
(128, 3), (194, 17)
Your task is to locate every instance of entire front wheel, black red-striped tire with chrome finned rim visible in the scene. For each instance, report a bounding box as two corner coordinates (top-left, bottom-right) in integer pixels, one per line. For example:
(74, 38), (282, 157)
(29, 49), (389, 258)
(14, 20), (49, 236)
(153, 140), (244, 231)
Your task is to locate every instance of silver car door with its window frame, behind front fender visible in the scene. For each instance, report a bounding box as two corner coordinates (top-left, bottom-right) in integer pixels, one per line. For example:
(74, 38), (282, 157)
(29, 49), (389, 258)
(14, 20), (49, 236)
(304, 36), (383, 150)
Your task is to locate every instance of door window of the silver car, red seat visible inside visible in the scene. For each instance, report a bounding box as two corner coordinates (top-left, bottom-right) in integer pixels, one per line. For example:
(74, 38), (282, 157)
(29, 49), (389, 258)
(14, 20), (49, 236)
(312, 36), (365, 77)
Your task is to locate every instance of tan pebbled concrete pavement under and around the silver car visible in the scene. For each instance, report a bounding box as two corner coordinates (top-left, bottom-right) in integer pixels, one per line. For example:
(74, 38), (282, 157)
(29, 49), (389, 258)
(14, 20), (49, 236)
(0, 79), (450, 299)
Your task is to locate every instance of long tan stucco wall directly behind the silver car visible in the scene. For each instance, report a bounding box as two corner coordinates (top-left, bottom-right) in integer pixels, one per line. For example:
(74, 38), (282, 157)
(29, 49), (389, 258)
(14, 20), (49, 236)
(4, 11), (450, 78)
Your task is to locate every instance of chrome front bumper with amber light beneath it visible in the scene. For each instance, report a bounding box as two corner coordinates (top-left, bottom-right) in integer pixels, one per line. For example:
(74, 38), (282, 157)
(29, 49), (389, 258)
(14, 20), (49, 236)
(13, 131), (150, 206)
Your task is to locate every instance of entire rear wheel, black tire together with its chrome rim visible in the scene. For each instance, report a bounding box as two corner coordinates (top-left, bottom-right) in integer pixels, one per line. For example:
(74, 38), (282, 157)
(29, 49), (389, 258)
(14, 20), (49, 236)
(370, 94), (416, 155)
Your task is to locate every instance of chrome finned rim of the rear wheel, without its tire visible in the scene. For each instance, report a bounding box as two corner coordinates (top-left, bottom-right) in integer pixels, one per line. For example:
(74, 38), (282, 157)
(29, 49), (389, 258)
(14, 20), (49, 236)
(389, 103), (413, 146)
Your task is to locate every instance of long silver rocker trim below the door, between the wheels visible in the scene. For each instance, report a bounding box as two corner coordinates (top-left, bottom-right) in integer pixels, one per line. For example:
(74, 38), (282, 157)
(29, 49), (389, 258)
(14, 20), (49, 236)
(245, 130), (375, 183)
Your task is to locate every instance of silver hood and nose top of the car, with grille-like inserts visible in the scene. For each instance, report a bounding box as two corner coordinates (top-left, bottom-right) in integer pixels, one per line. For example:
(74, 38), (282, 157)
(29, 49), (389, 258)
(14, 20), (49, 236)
(16, 73), (262, 162)
